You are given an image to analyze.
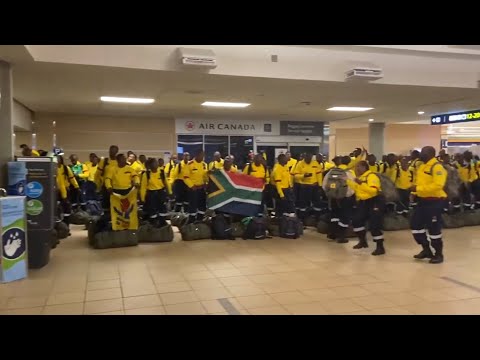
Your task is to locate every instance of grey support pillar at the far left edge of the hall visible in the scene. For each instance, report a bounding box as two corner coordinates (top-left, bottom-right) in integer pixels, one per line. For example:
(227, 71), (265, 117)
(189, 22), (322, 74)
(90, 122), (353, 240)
(0, 60), (14, 187)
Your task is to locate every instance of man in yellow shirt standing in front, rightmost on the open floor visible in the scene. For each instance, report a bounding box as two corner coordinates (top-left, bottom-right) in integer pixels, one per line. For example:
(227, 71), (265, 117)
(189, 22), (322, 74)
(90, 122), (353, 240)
(410, 146), (448, 264)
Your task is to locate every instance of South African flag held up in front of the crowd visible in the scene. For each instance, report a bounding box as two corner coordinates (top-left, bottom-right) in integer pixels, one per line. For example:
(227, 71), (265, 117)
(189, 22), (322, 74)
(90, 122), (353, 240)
(207, 169), (264, 216)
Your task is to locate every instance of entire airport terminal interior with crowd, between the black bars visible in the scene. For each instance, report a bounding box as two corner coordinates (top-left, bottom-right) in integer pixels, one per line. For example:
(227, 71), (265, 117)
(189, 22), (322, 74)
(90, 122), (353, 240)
(0, 45), (480, 315)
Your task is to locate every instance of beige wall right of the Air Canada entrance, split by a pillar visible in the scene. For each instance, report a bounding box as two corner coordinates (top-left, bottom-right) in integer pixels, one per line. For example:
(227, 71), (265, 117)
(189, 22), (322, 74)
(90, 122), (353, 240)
(329, 124), (441, 158)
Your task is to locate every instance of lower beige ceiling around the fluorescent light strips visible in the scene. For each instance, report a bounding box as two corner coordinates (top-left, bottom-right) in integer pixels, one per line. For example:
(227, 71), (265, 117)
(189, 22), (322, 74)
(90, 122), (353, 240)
(6, 61), (480, 127)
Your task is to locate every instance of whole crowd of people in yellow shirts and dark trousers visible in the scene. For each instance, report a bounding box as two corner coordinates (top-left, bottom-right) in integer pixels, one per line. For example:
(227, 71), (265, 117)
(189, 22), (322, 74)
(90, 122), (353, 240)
(50, 142), (480, 263)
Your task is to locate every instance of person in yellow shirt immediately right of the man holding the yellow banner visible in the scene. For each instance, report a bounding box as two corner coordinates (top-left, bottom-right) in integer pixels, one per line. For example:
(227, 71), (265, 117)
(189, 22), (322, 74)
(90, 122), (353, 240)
(140, 159), (172, 227)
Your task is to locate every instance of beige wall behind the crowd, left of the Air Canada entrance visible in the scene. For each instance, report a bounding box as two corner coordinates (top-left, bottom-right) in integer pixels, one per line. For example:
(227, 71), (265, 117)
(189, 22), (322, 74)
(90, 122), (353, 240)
(35, 113), (176, 161)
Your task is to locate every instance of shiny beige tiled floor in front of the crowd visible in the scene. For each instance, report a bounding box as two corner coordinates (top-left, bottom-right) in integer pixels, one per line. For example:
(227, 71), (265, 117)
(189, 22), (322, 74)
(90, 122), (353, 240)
(0, 227), (480, 315)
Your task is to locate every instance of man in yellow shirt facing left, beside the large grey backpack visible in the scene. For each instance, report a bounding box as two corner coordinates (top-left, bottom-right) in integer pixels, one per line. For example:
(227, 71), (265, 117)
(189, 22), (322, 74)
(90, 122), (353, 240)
(347, 161), (385, 256)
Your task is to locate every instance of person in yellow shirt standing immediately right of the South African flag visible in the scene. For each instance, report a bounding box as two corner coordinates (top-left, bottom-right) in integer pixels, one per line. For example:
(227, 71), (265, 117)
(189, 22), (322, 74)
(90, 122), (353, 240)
(273, 154), (295, 217)
